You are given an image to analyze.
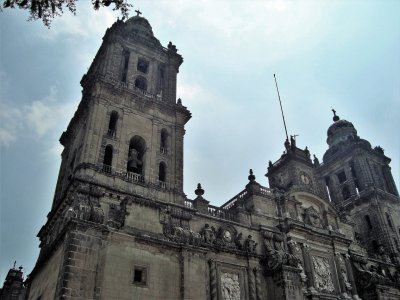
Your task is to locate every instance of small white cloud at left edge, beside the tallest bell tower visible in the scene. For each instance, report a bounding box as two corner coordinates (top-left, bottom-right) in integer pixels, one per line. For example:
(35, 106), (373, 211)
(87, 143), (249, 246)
(0, 86), (76, 146)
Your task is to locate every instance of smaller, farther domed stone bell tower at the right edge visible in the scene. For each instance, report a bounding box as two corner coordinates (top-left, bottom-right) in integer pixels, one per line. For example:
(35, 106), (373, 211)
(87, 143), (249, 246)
(319, 110), (400, 264)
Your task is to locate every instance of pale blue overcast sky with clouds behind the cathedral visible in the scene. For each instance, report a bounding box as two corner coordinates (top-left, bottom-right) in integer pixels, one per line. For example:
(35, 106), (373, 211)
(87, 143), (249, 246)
(0, 0), (400, 282)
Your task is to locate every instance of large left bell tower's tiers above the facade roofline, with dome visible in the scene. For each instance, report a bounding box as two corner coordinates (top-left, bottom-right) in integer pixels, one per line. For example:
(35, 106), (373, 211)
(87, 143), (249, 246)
(53, 15), (191, 208)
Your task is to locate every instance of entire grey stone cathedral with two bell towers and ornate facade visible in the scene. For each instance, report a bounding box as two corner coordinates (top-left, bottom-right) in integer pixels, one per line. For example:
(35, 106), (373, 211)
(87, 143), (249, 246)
(0, 14), (400, 300)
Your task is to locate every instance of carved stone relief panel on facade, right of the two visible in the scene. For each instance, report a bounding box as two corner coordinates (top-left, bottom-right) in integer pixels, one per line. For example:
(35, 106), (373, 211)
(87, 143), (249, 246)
(312, 256), (335, 293)
